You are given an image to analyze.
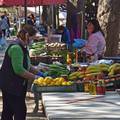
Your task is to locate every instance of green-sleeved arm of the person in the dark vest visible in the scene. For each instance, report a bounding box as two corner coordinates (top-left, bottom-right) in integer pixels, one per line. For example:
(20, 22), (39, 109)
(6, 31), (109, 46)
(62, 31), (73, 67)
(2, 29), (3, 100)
(8, 45), (35, 81)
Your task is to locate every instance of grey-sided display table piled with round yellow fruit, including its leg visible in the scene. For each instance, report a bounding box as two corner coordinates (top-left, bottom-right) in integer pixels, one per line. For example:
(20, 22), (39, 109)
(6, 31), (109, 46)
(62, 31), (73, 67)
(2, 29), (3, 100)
(31, 77), (77, 112)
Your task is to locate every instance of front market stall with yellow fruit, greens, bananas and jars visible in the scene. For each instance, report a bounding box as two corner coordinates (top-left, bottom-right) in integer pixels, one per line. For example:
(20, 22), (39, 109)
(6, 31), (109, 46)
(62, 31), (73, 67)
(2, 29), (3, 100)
(32, 61), (120, 113)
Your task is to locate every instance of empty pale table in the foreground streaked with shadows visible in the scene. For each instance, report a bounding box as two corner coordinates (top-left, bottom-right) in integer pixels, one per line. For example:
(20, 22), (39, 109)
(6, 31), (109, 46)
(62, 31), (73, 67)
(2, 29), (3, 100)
(42, 92), (120, 120)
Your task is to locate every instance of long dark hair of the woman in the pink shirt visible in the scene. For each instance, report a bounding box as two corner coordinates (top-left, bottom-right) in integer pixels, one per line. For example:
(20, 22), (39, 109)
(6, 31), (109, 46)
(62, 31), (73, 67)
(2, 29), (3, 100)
(87, 19), (104, 35)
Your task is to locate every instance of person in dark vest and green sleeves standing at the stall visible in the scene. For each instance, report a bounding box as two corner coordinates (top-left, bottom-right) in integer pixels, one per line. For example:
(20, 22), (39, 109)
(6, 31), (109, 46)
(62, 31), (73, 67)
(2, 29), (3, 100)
(0, 25), (39, 120)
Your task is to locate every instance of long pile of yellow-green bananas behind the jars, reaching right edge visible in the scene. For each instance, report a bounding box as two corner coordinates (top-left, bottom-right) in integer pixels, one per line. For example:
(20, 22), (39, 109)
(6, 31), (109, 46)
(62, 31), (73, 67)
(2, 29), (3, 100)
(68, 63), (120, 80)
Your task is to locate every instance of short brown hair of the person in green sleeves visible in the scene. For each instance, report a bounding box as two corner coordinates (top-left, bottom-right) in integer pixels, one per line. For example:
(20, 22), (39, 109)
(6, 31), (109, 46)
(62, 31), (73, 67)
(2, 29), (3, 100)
(17, 24), (37, 40)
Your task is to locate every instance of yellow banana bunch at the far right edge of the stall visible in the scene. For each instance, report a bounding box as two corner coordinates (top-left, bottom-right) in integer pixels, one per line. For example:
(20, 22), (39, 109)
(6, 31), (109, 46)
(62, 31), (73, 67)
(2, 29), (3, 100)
(108, 63), (120, 76)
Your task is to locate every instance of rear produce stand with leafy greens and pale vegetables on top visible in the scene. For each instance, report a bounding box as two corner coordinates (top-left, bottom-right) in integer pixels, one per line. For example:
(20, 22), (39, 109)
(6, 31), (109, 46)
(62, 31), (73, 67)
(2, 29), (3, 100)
(29, 41), (67, 65)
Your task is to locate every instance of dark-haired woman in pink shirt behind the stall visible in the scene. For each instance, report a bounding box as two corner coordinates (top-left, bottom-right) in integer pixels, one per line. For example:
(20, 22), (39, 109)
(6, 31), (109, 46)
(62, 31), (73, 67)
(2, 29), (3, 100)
(81, 20), (106, 61)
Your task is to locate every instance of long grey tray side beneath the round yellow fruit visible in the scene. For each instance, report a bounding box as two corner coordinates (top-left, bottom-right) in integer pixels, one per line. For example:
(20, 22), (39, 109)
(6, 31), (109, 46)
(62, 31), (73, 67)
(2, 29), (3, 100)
(32, 84), (77, 92)
